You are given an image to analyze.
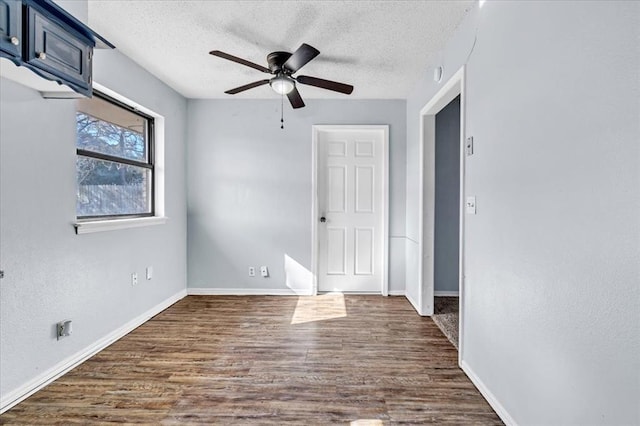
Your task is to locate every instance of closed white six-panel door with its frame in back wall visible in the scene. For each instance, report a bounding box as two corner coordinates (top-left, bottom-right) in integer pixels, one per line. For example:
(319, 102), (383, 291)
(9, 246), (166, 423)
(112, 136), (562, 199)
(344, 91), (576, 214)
(314, 126), (388, 295)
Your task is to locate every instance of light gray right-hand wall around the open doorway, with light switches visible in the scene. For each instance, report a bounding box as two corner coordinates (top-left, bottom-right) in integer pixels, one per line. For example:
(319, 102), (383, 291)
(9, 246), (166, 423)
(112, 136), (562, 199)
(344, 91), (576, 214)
(407, 1), (640, 425)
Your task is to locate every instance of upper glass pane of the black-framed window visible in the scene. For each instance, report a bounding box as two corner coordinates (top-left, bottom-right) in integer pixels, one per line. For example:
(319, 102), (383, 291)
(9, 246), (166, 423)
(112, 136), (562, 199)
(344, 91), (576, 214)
(76, 96), (149, 163)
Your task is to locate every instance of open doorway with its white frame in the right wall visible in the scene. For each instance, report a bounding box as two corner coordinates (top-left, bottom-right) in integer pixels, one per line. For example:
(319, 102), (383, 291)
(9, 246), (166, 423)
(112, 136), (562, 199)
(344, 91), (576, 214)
(418, 66), (465, 359)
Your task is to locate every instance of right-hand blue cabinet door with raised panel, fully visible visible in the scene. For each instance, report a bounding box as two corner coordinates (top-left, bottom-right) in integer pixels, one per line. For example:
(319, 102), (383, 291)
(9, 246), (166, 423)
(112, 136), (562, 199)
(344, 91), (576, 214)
(25, 8), (93, 91)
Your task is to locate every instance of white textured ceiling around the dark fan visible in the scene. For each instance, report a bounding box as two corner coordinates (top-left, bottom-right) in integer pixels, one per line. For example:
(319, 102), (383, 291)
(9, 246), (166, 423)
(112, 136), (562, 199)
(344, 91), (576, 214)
(89, 0), (474, 99)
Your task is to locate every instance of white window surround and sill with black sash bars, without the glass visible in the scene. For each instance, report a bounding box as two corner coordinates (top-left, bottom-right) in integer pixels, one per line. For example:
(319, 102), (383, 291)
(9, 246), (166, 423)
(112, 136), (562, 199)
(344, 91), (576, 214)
(73, 81), (167, 234)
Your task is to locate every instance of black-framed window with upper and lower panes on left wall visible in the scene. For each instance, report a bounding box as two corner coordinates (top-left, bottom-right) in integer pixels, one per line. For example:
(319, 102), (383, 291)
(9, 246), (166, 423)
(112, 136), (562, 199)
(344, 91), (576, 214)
(76, 91), (155, 220)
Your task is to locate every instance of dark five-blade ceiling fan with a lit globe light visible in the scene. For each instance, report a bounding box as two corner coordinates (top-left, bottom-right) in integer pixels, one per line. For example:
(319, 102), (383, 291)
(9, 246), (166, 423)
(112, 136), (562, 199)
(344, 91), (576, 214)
(209, 43), (353, 108)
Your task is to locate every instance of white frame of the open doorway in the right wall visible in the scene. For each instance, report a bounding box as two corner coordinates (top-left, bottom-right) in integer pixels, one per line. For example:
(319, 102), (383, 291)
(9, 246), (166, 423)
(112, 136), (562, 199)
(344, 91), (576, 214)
(418, 65), (466, 360)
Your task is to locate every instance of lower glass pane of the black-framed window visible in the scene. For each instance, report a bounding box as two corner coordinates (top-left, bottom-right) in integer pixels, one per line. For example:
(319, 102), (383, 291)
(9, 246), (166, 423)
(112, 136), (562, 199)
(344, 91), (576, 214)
(76, 155), (151, 217)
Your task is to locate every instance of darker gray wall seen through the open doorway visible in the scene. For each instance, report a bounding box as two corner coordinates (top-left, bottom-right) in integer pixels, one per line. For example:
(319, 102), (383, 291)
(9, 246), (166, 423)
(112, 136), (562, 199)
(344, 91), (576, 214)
(433, 97), (460, 292)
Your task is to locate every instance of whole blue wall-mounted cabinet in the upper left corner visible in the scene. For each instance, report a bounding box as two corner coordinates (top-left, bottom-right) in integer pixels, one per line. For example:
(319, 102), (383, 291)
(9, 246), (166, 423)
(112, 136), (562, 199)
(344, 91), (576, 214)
(0, 0), (114, 97)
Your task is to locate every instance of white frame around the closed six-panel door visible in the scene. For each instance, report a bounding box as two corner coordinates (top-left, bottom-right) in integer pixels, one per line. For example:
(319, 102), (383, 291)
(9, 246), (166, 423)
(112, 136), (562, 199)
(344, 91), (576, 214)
(311, 124), (389, 296)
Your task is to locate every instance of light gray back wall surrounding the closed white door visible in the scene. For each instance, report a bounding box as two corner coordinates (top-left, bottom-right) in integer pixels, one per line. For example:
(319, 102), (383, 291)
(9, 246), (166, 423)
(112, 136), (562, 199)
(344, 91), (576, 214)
(187, 98), (406, 292)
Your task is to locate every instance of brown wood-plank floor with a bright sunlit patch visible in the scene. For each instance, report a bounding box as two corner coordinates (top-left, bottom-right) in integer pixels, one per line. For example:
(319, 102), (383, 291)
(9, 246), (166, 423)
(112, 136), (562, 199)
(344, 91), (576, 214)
(0, 295), (502, 425)
